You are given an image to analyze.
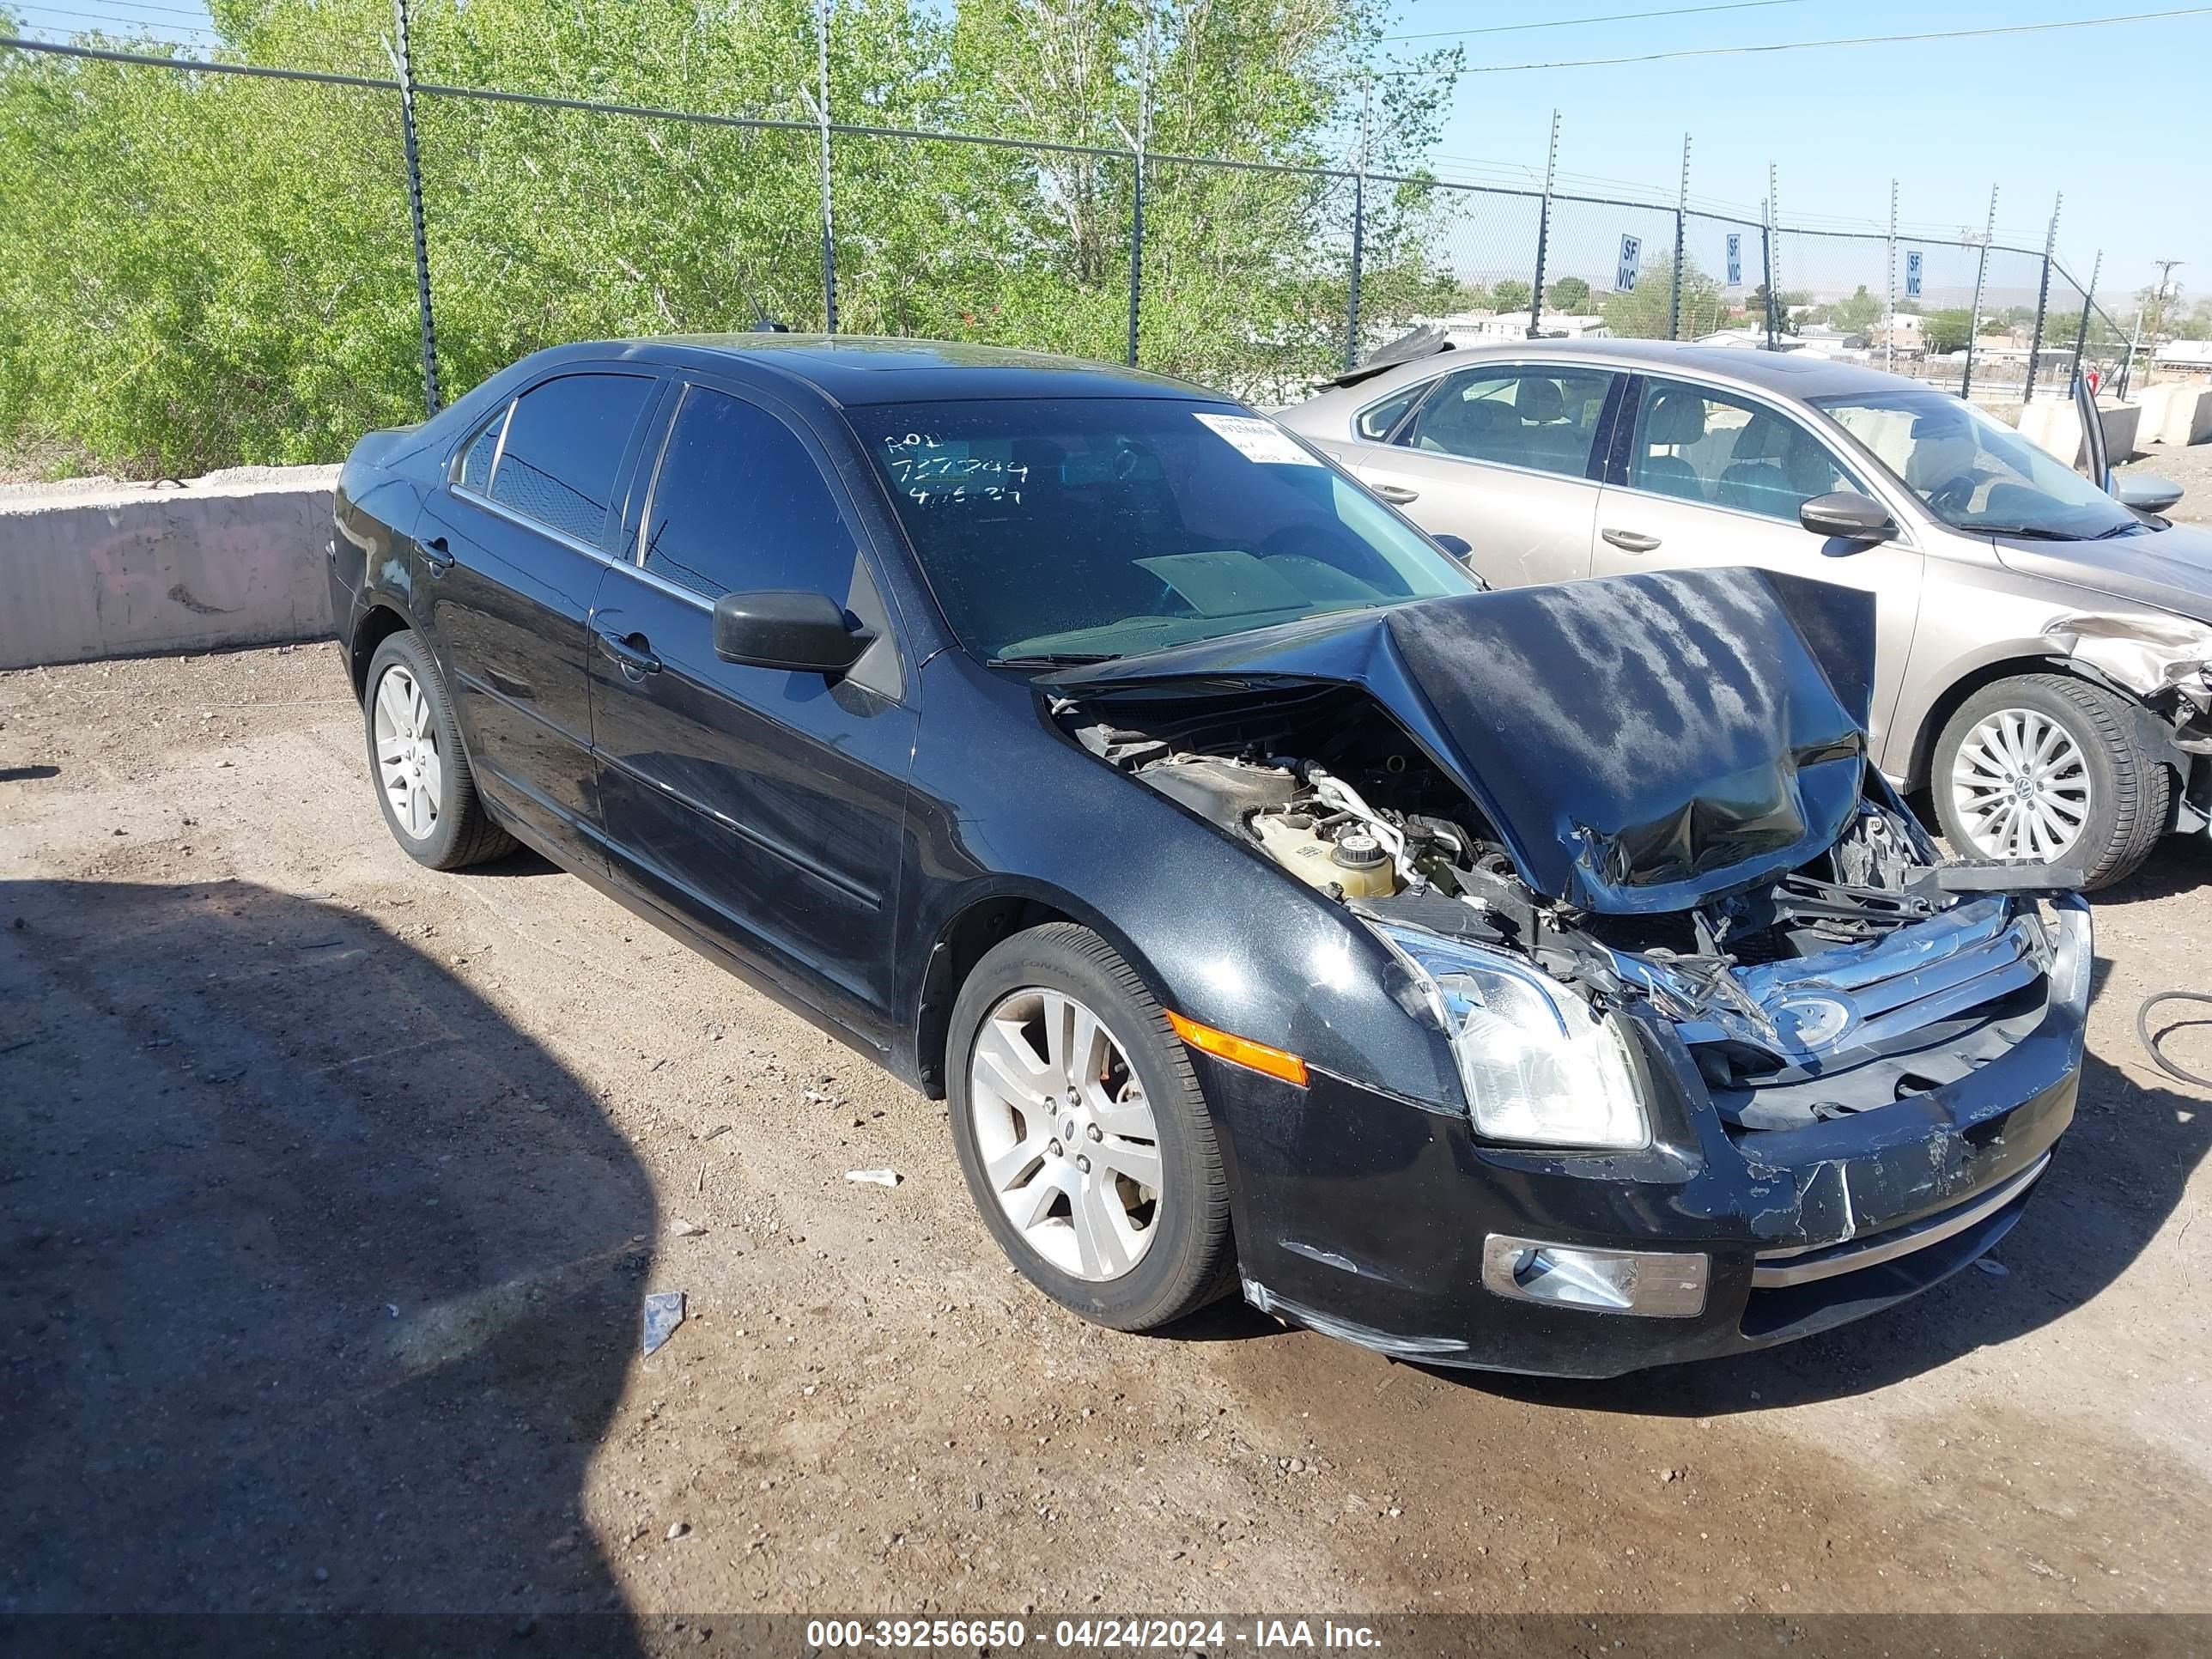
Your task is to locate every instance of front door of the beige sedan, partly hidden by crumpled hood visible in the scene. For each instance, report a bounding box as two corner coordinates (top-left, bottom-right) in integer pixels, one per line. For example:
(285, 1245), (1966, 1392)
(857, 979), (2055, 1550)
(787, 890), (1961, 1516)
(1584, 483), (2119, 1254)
(1590, 376), (1920, 754)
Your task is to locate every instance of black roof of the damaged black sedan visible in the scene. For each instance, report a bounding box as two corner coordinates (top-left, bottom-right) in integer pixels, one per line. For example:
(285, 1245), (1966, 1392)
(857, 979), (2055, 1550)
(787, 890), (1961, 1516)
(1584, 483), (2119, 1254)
(535, 334), (1232, 407)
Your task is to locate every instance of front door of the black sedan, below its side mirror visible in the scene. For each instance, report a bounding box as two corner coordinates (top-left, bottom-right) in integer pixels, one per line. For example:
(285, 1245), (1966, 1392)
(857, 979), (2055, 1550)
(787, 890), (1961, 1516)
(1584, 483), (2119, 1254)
(591, 380), (915, 1046)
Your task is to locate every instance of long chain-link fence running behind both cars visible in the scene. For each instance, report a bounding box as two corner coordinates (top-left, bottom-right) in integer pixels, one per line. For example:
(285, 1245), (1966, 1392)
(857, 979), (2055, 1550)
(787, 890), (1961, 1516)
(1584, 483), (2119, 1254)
(0, 22), (2128, 477)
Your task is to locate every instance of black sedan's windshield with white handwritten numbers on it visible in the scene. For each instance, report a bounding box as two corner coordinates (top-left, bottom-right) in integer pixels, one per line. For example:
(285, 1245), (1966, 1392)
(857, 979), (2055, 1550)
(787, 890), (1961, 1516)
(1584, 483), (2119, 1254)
(848, 398), (1480, 661)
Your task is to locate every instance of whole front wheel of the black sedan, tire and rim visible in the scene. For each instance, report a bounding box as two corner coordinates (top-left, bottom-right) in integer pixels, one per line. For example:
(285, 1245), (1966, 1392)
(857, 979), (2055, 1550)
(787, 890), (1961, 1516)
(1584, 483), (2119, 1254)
(945, 922), (1234, 1332)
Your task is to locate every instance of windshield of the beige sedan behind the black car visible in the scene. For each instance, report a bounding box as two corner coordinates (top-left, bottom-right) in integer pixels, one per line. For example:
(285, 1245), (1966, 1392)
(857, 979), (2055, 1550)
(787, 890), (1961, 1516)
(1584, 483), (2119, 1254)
(1812, 392), (2146, 542)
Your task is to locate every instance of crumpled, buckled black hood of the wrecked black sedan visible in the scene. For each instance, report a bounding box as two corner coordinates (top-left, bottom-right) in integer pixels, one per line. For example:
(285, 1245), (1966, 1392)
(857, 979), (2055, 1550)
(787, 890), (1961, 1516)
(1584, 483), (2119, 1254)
(1036, 571), (1874, 914)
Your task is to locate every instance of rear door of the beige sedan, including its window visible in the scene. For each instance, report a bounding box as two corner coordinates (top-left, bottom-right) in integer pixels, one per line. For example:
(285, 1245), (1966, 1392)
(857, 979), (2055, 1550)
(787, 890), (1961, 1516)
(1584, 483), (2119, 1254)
(1340, 362), (1621, 586)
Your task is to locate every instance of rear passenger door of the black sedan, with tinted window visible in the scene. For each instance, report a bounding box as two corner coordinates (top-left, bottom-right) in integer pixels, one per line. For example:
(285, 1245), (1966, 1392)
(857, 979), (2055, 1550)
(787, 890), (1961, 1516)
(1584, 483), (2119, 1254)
(414, 369), (657, 863)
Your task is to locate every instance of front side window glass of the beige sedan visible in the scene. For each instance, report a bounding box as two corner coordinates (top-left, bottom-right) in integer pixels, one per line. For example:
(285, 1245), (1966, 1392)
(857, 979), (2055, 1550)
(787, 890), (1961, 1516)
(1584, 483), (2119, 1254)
(1628, 380), (1860, 525)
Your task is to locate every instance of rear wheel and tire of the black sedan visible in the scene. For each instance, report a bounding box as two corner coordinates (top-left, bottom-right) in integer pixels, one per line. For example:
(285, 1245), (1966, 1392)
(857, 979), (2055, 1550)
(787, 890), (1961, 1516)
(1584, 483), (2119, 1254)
(361, 633), (515, 869)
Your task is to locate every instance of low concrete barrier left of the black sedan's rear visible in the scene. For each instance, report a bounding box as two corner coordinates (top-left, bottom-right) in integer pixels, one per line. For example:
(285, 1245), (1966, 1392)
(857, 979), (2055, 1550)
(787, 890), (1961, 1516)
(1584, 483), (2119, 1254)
(0, 467), (338, 668)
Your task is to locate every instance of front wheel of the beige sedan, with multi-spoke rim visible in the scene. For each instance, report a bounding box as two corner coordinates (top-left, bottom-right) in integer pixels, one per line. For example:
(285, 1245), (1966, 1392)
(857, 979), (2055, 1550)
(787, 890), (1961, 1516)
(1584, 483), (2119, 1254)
(1929, 675), (2172, 887)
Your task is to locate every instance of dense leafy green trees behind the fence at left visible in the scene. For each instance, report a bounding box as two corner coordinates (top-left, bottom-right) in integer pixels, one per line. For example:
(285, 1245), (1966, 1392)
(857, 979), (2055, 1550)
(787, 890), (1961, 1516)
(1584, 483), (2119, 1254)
(0, 0), (1467, 471)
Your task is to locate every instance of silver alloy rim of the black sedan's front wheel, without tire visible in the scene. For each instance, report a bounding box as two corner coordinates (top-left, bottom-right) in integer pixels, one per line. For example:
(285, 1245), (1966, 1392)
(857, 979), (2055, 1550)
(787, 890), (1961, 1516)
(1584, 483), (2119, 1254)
(969, 987), (1161, 1281)
